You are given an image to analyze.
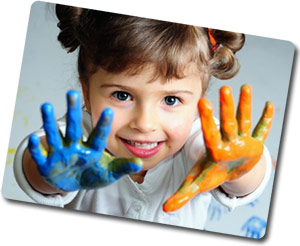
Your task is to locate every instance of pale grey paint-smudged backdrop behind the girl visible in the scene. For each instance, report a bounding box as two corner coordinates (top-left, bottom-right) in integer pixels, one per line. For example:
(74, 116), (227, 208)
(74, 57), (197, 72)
(2, 2), (294, 238)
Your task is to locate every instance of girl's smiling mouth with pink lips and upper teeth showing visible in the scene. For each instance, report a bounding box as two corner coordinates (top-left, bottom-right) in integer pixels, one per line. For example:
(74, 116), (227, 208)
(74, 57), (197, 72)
(120, 138), (164, 158)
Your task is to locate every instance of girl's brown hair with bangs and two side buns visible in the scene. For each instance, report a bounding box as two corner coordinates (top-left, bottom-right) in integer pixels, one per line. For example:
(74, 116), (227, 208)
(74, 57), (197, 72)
(56, 5), (245, 91)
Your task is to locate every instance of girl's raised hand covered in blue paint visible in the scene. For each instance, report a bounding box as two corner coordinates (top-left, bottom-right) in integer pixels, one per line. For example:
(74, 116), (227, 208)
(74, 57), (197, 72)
(28, 91), (142, 191)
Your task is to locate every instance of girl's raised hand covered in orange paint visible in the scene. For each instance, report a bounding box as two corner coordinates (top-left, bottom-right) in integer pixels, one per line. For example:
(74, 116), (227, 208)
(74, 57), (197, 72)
(163, 85), (274, 212)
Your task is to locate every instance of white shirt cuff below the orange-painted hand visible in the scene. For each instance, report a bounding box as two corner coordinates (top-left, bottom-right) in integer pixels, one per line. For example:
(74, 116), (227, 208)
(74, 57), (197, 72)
(211, 146), (272, 211)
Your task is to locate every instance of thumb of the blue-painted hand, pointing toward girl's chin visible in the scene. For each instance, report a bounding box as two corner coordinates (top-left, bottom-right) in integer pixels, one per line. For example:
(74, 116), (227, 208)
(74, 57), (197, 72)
(108, 158), (143, 178)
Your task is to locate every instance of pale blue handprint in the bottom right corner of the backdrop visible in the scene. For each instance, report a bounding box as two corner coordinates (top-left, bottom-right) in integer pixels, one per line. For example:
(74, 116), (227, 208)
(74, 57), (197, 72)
(241, 216), (267, 238)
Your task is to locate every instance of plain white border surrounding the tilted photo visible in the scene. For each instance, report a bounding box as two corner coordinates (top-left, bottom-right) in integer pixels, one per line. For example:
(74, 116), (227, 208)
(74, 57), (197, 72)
(0, 0), (300, 245)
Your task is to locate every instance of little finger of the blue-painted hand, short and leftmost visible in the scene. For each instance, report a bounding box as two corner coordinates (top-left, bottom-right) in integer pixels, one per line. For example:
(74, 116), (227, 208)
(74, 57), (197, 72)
(28, 134), (47, 167)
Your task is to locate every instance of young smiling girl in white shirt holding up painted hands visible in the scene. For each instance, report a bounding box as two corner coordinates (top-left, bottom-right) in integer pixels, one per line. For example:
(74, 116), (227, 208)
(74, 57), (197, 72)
(14, 5), (272, 229)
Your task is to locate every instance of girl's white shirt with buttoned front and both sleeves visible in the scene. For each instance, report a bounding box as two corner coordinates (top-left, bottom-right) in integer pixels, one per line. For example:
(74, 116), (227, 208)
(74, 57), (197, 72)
(14, 108), (272, 229)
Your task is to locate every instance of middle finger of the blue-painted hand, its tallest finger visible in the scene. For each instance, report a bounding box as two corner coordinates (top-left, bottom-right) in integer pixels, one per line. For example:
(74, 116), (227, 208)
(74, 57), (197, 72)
(66, 90), (82, 142)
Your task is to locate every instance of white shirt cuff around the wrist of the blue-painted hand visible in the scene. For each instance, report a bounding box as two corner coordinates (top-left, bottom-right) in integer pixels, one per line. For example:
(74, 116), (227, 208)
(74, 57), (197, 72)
(13, 119), (78, 207)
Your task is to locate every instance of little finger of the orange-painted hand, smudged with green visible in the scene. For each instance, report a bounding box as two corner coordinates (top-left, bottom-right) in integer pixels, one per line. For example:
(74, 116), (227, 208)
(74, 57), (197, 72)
(252, 102), (274, 142)
